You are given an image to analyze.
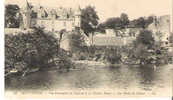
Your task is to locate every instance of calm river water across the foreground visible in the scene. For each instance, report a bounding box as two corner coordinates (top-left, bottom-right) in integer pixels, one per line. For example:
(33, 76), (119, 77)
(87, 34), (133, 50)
(6, 65), (172, 91)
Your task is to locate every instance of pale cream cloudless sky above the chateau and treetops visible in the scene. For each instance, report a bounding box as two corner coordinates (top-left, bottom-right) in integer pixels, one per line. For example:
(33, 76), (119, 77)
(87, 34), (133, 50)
(5, 0), (173, 22)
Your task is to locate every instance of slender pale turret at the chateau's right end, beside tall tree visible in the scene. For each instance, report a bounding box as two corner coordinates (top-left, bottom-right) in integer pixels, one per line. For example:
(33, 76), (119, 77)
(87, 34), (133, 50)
(75, 6), (81, 28)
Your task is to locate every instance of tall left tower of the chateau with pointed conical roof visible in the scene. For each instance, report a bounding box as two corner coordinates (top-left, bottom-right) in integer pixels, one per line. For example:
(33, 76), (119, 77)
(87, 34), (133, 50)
(22, 0), (31, 29)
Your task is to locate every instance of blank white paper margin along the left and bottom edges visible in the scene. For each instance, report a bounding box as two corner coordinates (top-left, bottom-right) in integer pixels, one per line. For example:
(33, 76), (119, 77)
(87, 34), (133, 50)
(0, 0), (171, 100)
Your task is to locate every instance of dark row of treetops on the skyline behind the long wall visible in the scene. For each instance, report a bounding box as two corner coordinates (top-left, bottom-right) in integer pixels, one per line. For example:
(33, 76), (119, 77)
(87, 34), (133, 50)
(98, 13), (154, 30)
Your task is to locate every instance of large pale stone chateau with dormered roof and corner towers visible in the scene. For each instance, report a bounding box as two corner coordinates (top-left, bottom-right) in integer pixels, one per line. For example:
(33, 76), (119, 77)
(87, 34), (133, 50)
(19, 1), (81, 31)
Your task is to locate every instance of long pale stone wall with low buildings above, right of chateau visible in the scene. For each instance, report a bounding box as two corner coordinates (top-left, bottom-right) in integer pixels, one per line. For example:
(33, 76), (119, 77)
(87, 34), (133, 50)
(93, 28), (141, 46)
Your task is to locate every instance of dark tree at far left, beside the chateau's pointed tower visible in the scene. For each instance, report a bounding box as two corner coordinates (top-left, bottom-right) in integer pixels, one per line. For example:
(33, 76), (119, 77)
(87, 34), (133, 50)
(5, 4), (20, 28)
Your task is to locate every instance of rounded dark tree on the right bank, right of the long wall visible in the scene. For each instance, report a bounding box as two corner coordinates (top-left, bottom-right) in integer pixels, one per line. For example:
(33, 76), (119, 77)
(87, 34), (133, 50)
(134, 30), (155, 64)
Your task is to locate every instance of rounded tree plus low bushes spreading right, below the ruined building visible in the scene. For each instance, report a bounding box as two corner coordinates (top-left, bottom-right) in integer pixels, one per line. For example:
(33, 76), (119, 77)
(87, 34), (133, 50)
(131, 30), (167, 64)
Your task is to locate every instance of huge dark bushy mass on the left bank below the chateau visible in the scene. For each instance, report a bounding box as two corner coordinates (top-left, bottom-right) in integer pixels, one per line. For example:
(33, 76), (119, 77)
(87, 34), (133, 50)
(5, 28), (71, 75)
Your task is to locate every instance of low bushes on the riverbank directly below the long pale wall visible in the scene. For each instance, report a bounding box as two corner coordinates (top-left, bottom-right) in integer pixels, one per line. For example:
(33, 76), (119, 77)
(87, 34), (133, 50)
(72, 46), (122, 64)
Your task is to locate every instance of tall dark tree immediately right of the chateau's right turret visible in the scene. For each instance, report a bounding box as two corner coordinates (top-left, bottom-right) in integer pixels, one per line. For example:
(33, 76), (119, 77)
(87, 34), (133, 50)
(81, 6), (99, 36)
